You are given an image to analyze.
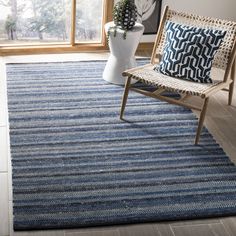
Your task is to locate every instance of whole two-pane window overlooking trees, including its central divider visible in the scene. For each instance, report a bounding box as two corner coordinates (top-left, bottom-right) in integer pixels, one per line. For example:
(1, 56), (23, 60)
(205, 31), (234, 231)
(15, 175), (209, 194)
(0, 0), (113, 53)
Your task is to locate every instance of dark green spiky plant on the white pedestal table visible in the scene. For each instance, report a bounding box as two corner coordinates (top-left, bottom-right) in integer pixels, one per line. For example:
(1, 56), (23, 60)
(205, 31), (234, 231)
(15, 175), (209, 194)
(107, 0), (137, 39)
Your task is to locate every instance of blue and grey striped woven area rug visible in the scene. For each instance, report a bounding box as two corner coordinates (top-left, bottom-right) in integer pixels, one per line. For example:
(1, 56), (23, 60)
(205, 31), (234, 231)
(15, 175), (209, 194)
(7, 60), (236, 230)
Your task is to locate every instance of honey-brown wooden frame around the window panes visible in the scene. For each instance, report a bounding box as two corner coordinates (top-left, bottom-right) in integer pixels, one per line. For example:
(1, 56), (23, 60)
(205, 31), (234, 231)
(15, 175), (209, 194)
(0, 0), (114, 56)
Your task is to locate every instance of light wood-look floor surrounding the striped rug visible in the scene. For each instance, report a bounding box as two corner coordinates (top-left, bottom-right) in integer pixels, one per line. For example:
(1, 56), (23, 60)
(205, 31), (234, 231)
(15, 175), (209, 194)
(0, 51), (236, 236)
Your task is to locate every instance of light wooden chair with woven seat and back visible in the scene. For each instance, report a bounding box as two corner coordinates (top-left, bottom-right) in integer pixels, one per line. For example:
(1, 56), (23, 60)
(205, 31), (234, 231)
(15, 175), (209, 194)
(120, 6), (236, 144)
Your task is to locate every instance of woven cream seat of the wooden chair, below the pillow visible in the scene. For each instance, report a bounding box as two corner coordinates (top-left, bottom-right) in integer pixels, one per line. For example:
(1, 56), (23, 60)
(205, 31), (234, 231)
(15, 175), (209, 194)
(123, 64), (224, 98)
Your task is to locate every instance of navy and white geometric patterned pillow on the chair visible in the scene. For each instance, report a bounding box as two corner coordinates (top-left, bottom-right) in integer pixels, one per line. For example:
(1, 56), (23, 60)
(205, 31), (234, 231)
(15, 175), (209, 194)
(154, 21), (226, 83)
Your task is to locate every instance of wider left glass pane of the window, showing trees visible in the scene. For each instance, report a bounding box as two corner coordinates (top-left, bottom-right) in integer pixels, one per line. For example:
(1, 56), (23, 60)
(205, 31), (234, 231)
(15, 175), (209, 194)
(0, 0), (71, 44)
